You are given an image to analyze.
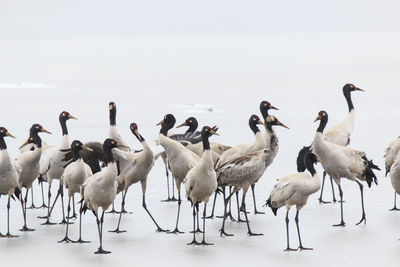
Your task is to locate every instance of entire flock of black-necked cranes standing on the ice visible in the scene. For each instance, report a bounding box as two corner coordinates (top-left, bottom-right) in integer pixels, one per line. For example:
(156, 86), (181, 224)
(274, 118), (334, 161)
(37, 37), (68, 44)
(0, 84), (400, 254)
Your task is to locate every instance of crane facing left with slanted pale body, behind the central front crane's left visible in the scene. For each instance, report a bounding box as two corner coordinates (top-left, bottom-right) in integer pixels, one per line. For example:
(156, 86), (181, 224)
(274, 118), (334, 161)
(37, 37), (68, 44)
(157, 114), (200, 233)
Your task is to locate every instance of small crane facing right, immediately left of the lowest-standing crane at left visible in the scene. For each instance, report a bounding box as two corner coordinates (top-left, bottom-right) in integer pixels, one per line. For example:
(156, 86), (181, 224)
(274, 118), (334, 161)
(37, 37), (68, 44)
(58, 140), (93, 243)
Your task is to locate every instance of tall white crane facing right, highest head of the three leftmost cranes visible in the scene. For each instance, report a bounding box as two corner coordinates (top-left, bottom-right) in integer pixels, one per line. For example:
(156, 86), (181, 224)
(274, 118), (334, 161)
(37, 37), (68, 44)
(39, 111), (76, 225)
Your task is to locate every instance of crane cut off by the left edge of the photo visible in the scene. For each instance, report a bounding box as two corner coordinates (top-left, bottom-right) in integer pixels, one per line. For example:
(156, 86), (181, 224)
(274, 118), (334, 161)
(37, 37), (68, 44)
(0, 127), (21, 237)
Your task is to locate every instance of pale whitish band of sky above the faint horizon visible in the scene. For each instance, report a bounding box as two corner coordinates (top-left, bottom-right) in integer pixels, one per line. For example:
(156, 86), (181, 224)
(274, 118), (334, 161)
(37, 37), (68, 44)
(0, 0), (400, 39)
